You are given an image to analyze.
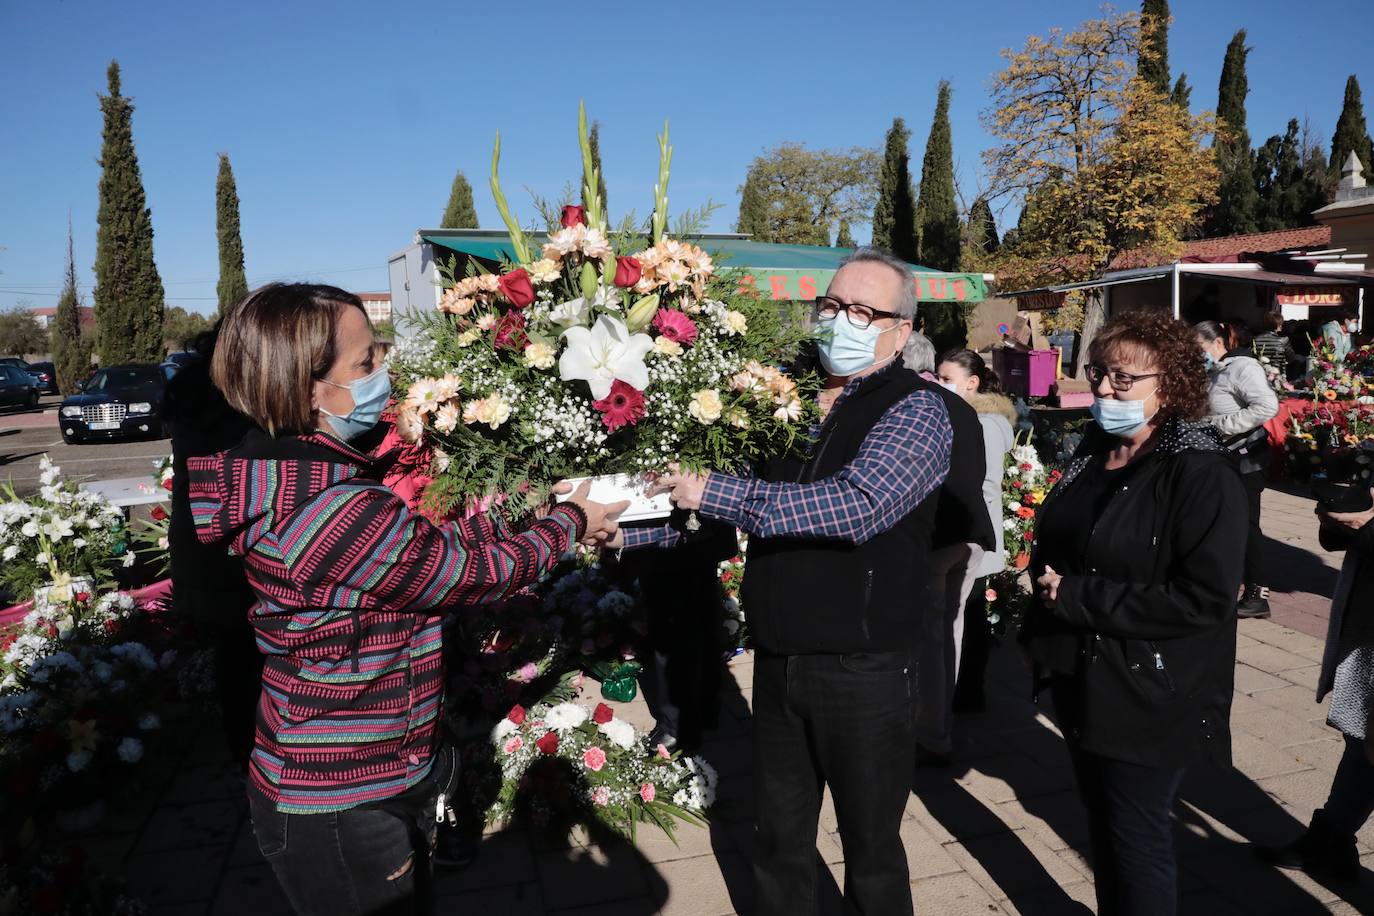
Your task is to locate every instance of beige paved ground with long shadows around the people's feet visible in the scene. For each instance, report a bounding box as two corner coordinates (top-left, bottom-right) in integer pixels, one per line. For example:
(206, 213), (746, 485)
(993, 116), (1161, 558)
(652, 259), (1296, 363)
(83, 492), (1374, 916)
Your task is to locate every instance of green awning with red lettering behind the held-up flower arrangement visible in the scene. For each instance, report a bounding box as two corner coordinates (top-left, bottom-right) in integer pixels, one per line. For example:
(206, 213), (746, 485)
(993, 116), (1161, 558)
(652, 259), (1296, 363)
(419, 229), (988, 302)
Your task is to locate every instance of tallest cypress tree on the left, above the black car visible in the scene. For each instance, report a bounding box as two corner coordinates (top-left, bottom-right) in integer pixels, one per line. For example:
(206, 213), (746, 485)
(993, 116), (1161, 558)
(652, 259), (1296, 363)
(95, 60), (165, 365)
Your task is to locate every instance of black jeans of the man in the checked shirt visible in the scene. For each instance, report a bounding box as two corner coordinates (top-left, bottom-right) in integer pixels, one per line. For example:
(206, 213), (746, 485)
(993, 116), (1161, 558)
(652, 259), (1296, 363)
(753, 651), (916, 916)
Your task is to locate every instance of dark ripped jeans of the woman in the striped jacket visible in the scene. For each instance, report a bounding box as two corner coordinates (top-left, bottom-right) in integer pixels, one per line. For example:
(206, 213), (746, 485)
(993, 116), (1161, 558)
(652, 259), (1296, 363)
(249, 779), (440, 916)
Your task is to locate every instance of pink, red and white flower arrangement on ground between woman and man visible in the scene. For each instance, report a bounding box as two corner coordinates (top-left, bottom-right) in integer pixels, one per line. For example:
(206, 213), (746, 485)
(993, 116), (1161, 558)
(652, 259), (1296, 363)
(491, 703), (716, 838)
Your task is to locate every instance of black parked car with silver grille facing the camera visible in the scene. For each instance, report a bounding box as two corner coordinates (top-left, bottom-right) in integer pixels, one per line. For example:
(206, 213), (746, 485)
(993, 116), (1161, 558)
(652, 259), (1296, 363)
(58, 365), (166, 442)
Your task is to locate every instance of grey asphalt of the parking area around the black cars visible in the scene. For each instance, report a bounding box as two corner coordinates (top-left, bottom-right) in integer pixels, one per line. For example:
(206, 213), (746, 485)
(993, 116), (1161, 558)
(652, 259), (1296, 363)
(0, 396), (172, 494)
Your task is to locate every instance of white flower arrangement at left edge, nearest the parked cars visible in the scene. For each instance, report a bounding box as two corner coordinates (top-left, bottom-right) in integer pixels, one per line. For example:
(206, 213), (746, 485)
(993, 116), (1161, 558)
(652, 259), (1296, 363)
(0, 455), (135, 600)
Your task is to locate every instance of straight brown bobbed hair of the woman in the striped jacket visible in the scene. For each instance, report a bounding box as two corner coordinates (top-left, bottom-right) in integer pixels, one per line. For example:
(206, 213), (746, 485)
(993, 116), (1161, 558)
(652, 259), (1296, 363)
(210, 283), (371, 435)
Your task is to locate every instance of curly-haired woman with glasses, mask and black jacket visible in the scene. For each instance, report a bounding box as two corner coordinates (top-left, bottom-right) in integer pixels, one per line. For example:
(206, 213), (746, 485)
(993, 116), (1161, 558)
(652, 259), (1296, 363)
(1022, 312), (1246, 916)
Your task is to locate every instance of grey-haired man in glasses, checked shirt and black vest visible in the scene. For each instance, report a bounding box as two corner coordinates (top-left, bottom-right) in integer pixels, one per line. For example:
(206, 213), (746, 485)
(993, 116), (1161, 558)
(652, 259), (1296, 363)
(624, 249), (952, 916)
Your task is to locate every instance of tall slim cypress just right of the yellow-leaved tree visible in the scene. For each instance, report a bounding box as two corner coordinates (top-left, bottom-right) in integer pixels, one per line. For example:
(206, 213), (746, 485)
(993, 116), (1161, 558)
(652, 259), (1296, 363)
(1208, 29), (1259, 235)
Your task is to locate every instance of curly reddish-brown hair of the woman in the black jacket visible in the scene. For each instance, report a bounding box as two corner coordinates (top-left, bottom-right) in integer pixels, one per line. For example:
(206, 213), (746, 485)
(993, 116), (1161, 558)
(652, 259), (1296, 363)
(1088, 309), (1223, 420)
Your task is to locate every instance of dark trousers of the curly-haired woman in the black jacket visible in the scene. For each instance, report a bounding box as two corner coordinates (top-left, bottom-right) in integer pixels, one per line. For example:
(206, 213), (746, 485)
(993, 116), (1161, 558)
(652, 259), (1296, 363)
(1070, 748), (1184, 916)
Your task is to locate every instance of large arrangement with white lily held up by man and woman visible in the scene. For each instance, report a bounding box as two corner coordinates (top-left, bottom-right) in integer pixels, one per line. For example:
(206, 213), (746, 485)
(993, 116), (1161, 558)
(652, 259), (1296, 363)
(392, 107), (815, 514)
